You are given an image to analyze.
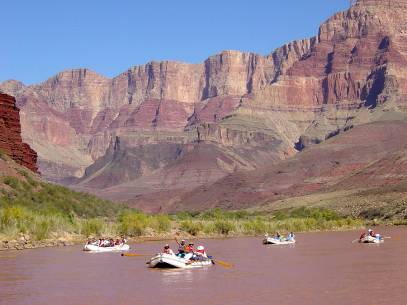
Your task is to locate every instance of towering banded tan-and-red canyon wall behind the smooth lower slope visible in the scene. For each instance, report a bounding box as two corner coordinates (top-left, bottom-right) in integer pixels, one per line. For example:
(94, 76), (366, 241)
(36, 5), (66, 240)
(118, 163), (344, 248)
(0, 0), (407, 209)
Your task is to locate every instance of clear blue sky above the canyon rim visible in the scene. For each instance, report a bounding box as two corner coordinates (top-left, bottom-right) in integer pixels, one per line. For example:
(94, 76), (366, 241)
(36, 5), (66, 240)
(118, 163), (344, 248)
(0, 0), (349, 84)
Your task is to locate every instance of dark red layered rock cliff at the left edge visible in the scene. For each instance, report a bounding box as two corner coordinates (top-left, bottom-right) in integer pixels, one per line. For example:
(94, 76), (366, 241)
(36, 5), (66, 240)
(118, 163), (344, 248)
(0, 93), (38, 172)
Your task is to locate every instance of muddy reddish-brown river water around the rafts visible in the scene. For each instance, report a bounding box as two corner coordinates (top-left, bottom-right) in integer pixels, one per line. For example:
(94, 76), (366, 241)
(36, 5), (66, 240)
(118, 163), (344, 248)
(0, 228), (407, 305)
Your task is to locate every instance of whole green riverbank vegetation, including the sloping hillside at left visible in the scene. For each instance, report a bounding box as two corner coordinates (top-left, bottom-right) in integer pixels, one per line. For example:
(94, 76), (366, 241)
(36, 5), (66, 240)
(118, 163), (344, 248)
(0, 171), (364, 245)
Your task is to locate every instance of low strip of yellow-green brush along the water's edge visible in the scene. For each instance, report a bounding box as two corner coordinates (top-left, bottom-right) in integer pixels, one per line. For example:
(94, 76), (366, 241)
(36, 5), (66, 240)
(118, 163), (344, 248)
(0, 205), (364, 240)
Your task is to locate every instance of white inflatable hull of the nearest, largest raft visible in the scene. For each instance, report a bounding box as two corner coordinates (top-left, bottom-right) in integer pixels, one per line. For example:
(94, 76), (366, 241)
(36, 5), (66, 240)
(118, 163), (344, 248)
(147, 253), (212, 269)
